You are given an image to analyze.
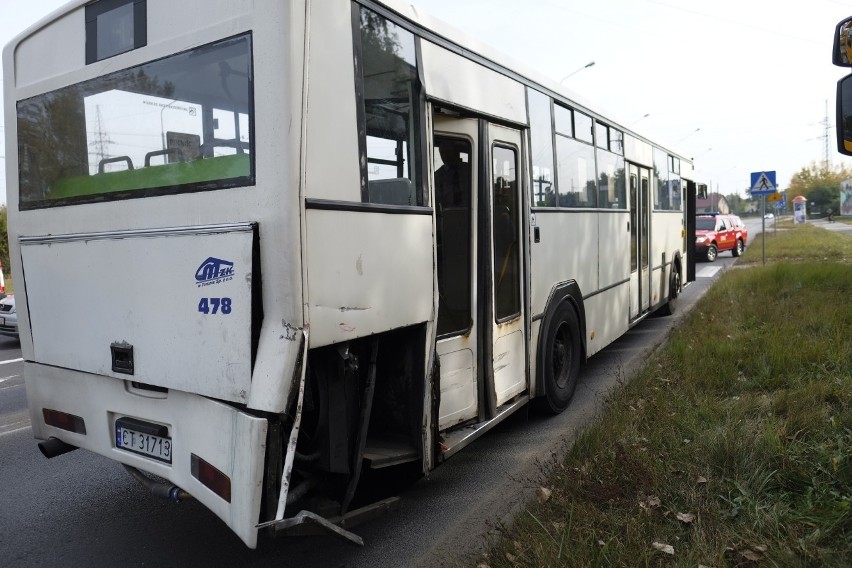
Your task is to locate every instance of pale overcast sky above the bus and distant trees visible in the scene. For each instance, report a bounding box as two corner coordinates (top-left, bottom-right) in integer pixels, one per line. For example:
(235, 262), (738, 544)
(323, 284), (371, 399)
(0, 0), (852, 202)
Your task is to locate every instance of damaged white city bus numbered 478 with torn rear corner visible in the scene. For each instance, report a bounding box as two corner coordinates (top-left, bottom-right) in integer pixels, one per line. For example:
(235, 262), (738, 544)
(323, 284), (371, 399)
(3, 0), (694, 547)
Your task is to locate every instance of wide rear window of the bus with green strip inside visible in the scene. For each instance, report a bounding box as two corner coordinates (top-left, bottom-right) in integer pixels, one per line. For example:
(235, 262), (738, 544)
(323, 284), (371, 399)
(17, 34), (254, 210)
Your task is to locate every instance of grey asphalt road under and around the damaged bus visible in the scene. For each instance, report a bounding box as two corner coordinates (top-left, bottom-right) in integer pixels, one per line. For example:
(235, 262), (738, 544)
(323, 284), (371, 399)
(0, 252), (733, 568)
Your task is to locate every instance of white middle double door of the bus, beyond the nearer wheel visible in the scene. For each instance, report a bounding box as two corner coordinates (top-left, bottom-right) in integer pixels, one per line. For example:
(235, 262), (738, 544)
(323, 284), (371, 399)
(627, 164), (651, 320)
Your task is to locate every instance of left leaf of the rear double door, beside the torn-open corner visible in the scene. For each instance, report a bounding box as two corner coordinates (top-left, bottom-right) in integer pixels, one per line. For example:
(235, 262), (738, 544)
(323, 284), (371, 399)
(432, 113), (481, 430)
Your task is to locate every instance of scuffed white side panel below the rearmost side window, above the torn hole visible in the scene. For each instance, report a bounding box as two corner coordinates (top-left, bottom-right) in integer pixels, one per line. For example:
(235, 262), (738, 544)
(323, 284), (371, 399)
(306, 209), (433, 348)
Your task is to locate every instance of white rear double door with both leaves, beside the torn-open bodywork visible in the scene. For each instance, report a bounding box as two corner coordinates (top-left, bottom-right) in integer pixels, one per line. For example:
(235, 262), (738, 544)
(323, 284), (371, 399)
(432, 112), (527, 457)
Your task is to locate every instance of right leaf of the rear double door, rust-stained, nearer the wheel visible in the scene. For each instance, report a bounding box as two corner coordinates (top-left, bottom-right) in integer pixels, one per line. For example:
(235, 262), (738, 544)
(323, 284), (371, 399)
(480, 124), (527, 407)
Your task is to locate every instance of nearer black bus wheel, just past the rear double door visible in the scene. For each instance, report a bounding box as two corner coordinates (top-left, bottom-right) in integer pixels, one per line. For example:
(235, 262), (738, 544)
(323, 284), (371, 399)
(536, 302), (582, 414)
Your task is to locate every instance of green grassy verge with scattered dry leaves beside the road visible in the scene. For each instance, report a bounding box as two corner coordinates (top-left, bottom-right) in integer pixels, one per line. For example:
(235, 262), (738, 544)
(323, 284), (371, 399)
(478, 225), (852, 568)
